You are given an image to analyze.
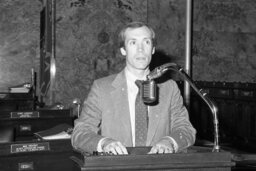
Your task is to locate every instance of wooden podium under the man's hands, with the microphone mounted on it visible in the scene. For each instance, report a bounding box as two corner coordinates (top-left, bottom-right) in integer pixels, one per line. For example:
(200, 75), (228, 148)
(71, 147), (235, 171)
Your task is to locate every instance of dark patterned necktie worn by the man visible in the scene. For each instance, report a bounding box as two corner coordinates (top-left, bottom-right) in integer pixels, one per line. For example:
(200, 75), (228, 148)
(135, 80), (148, 146)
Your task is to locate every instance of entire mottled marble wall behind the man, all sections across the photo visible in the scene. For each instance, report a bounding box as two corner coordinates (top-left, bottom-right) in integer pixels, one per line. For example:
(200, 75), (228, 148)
(0, 0), (256, 106)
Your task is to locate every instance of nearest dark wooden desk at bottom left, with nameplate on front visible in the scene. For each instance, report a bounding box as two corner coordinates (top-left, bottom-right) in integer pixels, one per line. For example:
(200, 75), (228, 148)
(0, 140), (75, 171)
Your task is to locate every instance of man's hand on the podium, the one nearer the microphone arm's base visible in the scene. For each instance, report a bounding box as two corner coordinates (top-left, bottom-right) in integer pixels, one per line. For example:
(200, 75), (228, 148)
(149, 137), (175, 154)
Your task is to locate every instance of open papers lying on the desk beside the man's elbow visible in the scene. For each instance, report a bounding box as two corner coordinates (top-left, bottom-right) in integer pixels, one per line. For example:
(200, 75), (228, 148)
(34, 124), (73, 140)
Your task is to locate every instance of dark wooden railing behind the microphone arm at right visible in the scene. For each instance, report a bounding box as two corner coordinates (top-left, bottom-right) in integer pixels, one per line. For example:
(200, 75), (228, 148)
(177, 81), (256, 151)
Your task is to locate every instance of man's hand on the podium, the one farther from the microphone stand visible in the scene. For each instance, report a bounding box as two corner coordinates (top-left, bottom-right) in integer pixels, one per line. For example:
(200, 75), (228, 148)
(102, 138), (128, 155)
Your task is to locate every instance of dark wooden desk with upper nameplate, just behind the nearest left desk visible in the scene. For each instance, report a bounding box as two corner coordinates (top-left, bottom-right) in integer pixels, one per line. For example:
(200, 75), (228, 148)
(0, 109), (74, 141)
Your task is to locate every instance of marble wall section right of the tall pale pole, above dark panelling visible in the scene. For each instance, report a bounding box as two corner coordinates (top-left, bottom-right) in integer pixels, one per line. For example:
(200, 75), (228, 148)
(193, 0), (256, 83)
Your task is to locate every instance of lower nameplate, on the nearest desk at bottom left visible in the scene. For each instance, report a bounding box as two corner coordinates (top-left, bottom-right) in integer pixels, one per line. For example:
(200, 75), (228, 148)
(11, 142), (50, 153)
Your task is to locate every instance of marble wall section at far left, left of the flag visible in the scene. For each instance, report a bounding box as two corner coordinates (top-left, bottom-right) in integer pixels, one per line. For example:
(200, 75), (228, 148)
(0, 0), (42, 92)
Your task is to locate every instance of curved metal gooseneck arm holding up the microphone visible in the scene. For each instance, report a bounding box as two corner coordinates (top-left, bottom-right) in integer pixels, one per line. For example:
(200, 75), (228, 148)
(147, 63), (220, 152)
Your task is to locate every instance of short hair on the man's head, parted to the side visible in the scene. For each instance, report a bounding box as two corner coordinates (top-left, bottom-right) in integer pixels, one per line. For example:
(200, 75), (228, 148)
(118, 21), (156, 48)
